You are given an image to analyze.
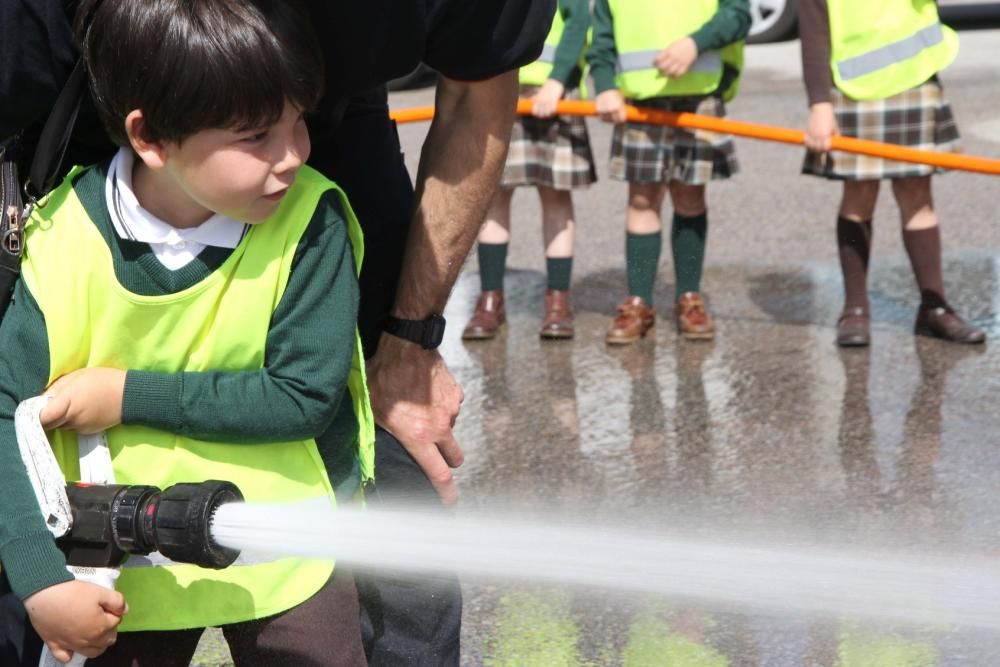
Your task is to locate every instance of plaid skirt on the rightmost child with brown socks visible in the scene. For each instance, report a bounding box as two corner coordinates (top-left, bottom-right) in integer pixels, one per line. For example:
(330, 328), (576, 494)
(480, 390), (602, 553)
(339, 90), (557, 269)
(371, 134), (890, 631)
(802, 79), (959, 181)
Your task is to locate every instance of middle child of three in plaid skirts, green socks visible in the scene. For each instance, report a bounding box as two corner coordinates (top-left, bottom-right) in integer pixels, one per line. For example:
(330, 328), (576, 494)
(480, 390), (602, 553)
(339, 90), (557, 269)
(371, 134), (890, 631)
(587, 0), (750, 345)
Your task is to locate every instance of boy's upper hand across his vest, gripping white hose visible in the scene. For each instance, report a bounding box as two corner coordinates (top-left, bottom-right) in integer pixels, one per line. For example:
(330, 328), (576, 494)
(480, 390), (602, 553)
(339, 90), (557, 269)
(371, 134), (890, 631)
(40, 368), (125, 433)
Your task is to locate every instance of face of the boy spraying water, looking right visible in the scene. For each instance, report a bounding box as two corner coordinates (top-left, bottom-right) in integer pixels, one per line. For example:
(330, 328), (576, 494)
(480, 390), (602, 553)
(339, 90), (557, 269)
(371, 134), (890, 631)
(153, 101), (310, 223)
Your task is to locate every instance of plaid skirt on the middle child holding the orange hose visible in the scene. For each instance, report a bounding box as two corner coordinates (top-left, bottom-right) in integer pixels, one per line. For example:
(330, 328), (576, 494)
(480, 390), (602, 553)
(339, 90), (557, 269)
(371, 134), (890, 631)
(611, 97), (740, 185)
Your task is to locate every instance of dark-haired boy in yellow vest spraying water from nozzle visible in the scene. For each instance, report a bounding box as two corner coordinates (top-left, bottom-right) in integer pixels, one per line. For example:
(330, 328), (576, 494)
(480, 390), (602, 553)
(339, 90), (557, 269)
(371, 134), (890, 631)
(0, 0), (373, 665)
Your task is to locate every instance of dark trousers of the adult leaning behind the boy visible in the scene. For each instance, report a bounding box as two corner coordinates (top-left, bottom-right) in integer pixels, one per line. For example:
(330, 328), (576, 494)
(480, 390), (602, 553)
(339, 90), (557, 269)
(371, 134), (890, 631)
(309, 88), (462, 667)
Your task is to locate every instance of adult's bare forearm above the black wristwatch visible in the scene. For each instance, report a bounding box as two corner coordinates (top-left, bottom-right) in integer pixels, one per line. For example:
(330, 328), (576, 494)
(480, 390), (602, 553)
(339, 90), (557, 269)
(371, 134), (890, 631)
(393, 72), (517, 319)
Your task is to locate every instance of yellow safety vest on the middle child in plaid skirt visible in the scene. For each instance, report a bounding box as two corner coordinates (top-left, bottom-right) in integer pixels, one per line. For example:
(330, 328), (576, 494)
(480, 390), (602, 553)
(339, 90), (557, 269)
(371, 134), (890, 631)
(608, 0), (743, 101)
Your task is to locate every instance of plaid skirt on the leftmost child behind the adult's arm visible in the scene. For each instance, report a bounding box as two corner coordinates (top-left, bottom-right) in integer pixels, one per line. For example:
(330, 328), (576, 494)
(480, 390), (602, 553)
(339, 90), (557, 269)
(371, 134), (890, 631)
(500, 87), (597, 190)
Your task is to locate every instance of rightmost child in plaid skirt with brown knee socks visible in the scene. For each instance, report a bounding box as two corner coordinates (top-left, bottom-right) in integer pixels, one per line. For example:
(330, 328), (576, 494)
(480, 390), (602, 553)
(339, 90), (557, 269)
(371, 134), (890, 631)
(800, 0), (986, 347)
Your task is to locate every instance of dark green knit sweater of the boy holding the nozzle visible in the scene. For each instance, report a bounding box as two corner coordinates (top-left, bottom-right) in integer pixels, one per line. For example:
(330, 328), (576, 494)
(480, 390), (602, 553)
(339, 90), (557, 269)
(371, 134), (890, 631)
(0, 160), (360, 599)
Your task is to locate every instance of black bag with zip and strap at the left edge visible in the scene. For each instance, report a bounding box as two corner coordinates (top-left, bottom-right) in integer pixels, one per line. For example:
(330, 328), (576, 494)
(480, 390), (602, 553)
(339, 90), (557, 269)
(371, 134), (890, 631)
(0, 60), (87, 319)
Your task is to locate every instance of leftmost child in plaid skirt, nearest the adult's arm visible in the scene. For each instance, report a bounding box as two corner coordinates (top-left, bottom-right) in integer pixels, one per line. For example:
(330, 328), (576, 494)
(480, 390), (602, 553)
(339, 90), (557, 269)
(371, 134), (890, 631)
(462, 0), (597, 340)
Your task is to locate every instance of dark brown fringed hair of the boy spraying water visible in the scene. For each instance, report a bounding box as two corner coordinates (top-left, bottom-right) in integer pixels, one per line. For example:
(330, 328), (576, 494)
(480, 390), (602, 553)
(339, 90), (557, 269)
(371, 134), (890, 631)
(76, 0), (323, 146)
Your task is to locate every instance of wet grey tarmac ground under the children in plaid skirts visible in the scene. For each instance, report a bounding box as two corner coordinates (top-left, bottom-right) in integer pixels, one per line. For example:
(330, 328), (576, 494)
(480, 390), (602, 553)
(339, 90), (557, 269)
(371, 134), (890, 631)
(193, 30), (1000, 667)
